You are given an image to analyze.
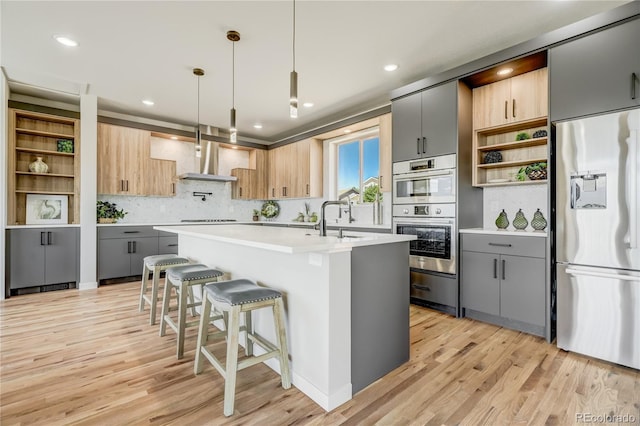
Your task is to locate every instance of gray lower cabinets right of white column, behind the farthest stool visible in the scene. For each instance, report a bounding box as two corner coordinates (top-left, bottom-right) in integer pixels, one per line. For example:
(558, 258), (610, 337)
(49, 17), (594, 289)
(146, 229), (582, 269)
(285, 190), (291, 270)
(98, 226), (178, 280)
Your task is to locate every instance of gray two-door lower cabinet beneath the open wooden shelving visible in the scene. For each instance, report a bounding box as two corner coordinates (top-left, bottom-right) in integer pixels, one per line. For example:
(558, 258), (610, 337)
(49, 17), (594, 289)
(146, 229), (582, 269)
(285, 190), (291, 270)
(6, 227), (80, 290)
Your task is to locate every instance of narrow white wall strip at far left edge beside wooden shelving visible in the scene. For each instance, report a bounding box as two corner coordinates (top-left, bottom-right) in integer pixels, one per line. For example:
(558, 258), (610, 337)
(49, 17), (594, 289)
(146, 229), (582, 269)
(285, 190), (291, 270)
(0, 71), (9, 300)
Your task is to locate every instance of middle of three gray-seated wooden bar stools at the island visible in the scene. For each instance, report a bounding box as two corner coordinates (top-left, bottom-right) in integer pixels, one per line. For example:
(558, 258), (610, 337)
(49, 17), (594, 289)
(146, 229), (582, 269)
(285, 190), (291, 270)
(160, 263), (224, 359)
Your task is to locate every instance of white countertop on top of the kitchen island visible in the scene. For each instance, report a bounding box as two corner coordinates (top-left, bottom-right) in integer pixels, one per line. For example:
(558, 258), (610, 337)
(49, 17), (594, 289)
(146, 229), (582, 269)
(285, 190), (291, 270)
(154, 223), (416, 253)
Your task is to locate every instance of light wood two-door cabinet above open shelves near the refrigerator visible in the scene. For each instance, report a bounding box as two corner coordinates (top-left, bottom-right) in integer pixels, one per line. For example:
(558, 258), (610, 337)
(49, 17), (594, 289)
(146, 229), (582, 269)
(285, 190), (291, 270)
(473, 68), (548, 130)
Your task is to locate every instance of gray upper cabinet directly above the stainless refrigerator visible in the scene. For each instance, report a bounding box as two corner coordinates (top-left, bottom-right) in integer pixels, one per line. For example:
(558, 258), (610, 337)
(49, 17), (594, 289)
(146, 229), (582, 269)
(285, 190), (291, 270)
(549, 19), (640, 121)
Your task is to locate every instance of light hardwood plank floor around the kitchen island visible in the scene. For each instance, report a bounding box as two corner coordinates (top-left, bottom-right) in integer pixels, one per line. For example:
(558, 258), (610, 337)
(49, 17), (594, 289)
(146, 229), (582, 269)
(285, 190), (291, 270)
(0, 282), (640, 426)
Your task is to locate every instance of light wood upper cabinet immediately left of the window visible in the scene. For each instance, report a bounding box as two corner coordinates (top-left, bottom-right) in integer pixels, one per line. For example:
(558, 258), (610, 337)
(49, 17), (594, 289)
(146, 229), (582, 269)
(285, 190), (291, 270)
(268, 138), (322, 199)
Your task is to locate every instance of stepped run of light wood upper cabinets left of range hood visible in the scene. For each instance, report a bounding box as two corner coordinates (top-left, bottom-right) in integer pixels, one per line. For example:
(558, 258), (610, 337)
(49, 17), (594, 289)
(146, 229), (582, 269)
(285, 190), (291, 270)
(98, 123), (176, 196)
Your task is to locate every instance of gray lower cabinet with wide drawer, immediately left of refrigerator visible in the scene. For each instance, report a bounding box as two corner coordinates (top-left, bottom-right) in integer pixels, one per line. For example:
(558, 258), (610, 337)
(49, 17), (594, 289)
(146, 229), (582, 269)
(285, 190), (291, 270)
(460, 234), (547, 336)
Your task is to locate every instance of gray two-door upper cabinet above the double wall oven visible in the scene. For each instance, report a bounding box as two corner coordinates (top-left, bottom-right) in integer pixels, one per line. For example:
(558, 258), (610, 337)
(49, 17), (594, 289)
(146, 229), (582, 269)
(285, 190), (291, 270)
(391, 81), (458, 162)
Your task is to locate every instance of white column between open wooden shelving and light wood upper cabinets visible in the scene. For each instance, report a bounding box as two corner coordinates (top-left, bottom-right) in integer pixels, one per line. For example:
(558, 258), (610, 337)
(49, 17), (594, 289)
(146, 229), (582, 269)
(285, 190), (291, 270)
(78, 95), (98, 290)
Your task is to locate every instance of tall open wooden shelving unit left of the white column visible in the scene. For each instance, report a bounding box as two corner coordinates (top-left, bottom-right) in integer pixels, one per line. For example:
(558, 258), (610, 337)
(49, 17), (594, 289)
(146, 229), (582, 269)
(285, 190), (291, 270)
(7, 109), (80, 225)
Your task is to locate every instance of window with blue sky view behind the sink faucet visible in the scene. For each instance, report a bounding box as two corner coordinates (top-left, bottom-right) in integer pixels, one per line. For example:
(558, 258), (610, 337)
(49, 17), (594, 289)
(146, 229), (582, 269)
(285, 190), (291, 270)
(329, 127), (380, 203)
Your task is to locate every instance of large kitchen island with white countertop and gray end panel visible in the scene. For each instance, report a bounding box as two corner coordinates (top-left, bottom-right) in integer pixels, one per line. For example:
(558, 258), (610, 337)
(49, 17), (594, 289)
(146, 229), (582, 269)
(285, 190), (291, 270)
(156, 225), (415, 411)
